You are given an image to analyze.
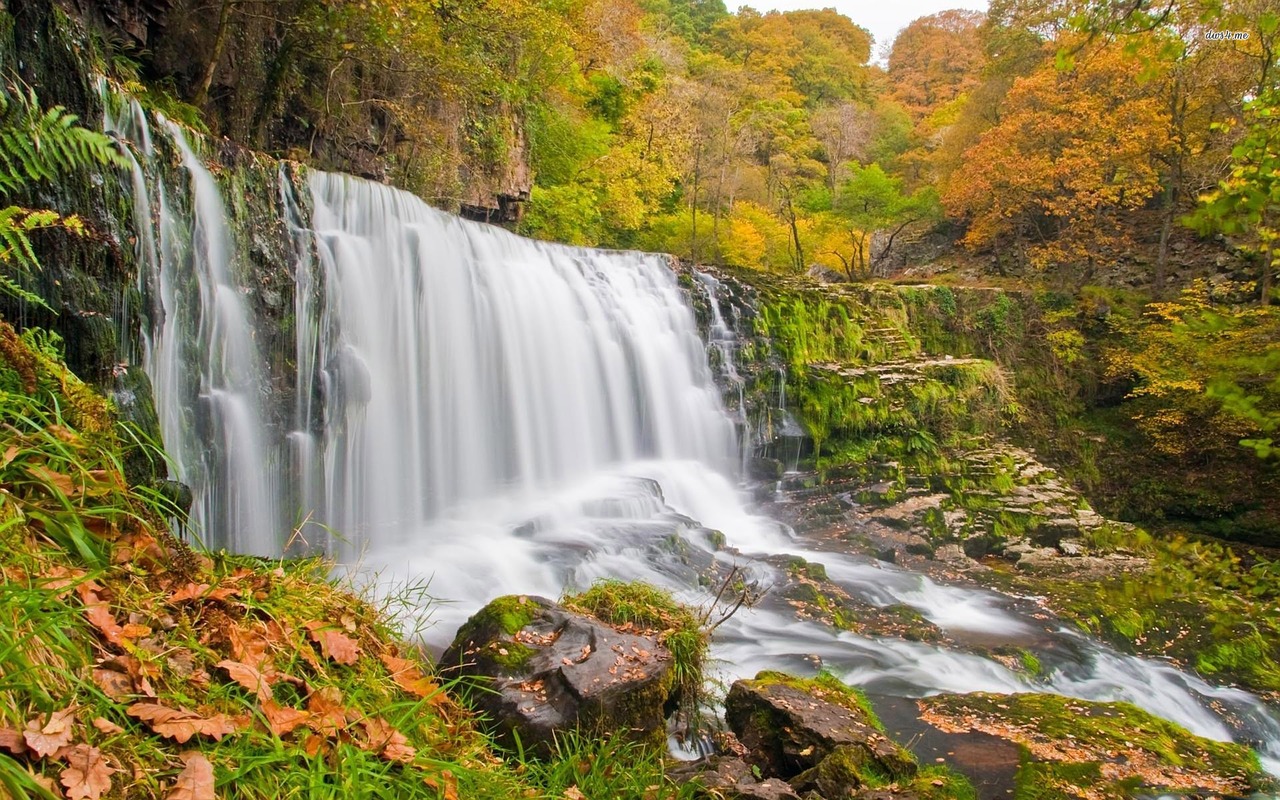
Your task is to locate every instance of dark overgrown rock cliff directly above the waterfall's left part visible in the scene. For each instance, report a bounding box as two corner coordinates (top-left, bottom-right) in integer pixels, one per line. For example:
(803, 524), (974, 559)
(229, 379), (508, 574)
(31, 0), (532, 223)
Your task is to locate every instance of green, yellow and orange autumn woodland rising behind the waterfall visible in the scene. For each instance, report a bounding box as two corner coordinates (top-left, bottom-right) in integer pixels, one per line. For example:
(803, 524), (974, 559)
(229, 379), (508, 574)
(15, 0), (1280, 543)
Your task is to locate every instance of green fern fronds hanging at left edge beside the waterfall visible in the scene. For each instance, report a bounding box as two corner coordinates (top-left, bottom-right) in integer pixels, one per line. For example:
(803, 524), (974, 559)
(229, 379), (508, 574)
(0, 83), (124, 308)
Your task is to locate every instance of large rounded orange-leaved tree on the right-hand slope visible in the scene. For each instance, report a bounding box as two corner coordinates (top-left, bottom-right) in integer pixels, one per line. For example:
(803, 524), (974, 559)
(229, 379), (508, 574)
(943, 40), (1169, 275)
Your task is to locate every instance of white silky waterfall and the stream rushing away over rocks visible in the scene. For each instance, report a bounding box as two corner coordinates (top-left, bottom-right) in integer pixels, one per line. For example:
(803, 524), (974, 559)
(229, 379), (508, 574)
(99, 96), (1280, 771)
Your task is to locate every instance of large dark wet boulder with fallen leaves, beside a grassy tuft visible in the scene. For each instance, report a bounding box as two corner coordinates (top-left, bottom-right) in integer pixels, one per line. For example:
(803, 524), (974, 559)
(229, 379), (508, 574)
(440, 596), (673, 755)
